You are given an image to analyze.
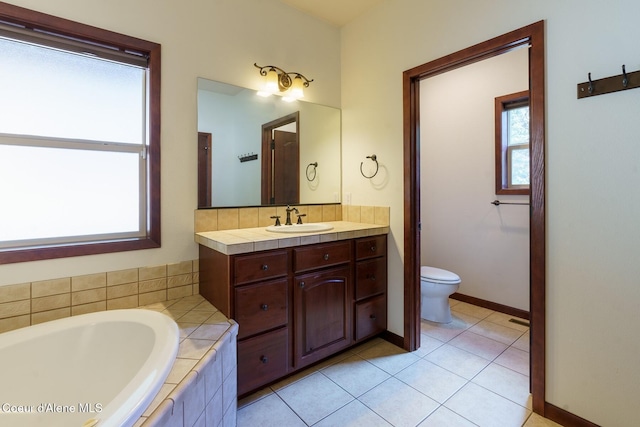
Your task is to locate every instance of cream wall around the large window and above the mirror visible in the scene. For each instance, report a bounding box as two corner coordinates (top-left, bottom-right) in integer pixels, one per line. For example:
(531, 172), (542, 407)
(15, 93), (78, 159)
(0, 0), (340, 285)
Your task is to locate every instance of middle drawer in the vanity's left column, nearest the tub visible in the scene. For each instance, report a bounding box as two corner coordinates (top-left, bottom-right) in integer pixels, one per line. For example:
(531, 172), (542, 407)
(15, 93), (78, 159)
(235, 278), (289, 339)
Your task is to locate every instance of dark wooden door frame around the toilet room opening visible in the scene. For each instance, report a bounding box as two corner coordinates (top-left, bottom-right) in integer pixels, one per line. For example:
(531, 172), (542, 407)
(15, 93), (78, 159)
(403, 21), (546, 415)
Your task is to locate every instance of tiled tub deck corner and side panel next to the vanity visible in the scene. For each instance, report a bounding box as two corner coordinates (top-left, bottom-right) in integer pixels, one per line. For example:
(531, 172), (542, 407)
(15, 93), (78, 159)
(134, 295), (238, 427)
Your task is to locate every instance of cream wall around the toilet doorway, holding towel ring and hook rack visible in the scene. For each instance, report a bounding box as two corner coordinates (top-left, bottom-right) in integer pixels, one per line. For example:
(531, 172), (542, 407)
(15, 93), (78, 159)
(342, 0), (640, 426)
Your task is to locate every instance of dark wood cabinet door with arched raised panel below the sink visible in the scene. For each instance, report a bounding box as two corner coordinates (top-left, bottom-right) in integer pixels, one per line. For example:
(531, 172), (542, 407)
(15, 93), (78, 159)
(293, 266), (353, 368)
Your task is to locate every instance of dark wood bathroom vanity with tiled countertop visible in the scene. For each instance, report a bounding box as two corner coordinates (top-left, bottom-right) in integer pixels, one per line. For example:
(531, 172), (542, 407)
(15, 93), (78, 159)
(196, 221), (388, 396)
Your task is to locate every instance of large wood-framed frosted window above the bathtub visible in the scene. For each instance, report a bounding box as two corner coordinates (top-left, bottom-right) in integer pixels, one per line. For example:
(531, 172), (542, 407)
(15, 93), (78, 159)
(0, 5), (160, 263)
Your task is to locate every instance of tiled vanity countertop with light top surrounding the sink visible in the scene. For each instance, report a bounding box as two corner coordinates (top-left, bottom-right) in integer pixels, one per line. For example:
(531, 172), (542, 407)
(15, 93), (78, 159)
(195, 221), (389, 255)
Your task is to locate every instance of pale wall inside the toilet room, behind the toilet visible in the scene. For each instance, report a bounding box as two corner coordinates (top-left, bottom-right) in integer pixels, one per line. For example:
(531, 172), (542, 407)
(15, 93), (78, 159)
(420, 48), (529, 311)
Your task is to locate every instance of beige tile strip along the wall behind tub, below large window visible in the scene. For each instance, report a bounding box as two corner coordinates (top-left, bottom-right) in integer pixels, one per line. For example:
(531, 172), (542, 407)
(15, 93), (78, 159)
(0, 259), (200, 333)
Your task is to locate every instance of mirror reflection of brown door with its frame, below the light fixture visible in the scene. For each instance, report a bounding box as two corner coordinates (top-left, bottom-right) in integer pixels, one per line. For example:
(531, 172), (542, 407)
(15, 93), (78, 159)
(261, 112), (300, 205)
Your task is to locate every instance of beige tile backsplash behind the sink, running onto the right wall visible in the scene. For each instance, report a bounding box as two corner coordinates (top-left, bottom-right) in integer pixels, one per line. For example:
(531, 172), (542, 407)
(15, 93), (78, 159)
(194, 205), (390, 233)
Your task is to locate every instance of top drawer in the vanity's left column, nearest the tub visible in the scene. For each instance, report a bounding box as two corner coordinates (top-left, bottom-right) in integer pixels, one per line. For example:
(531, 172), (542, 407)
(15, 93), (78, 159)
(234, 251), (288, 285)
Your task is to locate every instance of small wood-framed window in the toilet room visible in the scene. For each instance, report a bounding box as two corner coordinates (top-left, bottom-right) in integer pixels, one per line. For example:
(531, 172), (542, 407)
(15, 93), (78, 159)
(495, 91), (530, 194)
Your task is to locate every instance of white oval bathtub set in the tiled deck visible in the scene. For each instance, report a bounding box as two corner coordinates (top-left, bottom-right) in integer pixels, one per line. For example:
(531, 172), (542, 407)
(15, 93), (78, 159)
(0, 309), (179, 427)
